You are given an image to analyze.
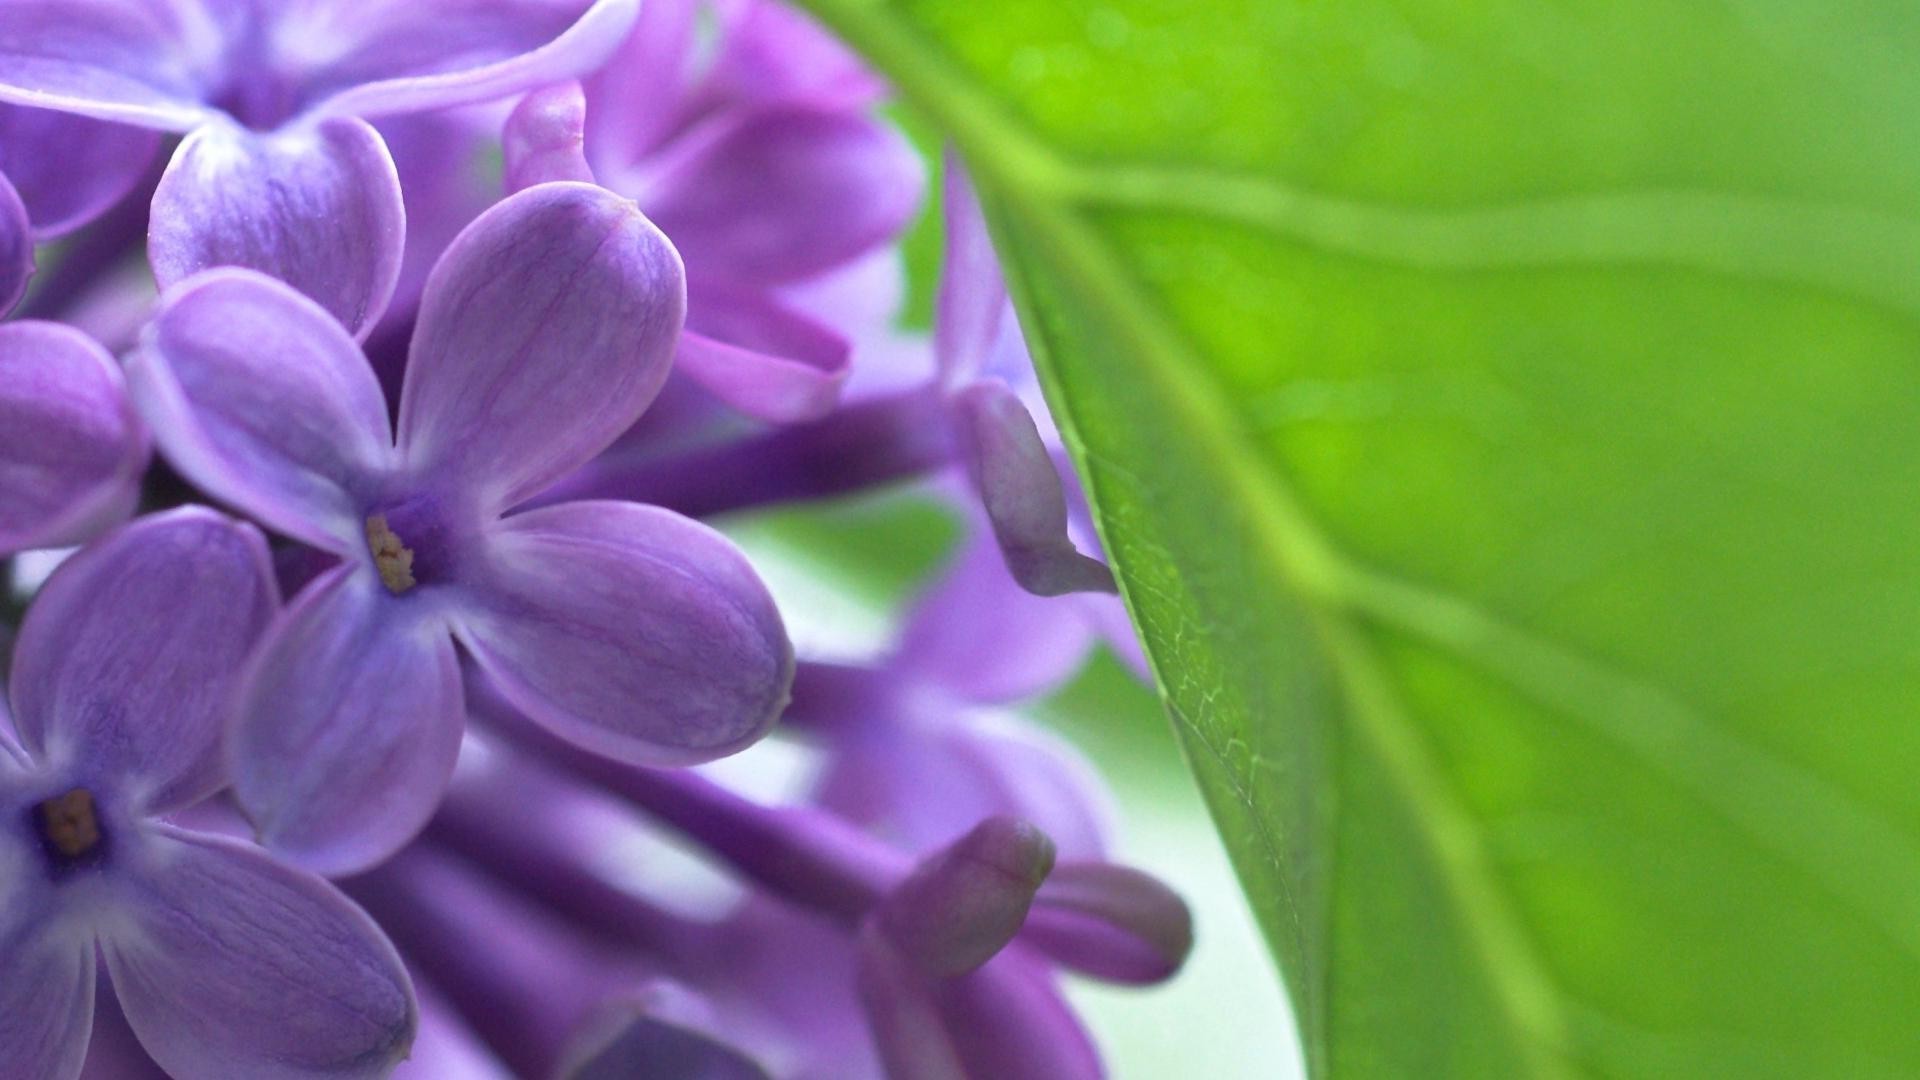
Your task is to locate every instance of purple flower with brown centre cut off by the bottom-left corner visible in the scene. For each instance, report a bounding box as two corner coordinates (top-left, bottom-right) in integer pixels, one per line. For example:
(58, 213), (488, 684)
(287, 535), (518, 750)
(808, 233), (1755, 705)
(0, 509), (415, 1080)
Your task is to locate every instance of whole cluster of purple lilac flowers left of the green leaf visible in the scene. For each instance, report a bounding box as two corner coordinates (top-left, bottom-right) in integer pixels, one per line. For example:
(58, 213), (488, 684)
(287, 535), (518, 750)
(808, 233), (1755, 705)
(0, 0), (1190, 1080)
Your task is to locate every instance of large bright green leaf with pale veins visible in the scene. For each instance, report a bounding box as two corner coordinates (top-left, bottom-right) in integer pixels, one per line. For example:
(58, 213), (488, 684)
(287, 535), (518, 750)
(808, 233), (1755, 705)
(808, 0), (1920, 1076)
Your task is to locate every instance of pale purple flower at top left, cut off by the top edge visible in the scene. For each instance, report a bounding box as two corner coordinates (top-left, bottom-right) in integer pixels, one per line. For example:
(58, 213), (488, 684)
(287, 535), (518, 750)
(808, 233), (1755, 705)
(0, 0), (636, 332)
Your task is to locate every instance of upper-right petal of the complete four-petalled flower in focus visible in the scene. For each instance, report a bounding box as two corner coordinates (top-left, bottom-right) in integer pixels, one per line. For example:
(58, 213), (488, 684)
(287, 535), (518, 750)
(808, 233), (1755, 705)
(399, 184), (685, 511)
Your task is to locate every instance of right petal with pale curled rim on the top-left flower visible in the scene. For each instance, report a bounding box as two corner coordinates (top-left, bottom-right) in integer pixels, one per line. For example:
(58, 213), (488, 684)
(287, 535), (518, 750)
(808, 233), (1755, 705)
(296, 0), (639, 117)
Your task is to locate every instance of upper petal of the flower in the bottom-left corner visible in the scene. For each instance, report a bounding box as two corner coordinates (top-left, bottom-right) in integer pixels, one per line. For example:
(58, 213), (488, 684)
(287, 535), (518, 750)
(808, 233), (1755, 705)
(12, 507), (278, 811)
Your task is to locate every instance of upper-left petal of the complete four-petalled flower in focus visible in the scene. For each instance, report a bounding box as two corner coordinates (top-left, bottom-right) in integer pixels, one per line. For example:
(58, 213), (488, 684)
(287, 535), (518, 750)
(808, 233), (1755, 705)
(127, 269), (394, 553)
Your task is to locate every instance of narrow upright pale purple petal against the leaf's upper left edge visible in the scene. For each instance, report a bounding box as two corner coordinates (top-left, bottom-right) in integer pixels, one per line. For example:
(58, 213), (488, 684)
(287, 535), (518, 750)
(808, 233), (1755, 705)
(933, 152), (1018, 388)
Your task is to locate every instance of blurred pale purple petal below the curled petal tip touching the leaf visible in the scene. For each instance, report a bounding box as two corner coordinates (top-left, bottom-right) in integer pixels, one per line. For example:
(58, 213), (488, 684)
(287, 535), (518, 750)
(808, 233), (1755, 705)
(893, 530), (1117, 703)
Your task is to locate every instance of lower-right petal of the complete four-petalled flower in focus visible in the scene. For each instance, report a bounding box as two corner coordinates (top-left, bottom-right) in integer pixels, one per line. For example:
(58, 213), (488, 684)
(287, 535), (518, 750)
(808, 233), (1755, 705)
(459, 502), (793, 765)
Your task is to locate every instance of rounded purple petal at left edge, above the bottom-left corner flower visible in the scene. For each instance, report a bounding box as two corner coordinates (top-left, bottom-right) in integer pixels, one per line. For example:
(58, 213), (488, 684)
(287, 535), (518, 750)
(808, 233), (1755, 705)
(0, 321), (148, 555)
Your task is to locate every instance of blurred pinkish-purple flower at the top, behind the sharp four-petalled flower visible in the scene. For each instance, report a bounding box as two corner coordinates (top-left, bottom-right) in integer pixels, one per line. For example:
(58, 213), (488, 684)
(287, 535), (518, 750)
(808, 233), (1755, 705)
(505, 0), (925, 423)
